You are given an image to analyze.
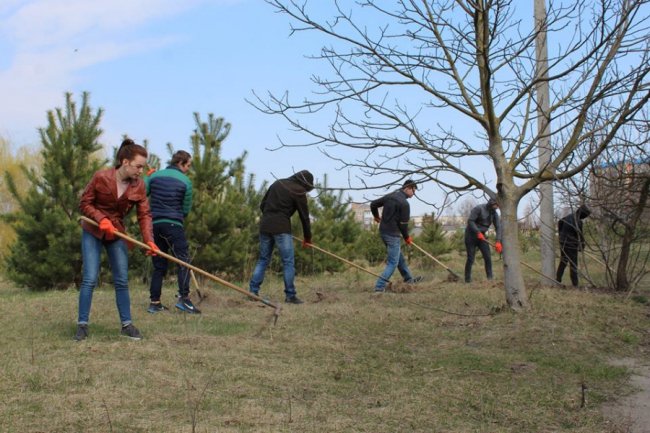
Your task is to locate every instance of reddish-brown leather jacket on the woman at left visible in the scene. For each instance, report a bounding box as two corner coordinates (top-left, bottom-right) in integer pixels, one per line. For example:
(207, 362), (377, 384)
(79, 168), (153, 243)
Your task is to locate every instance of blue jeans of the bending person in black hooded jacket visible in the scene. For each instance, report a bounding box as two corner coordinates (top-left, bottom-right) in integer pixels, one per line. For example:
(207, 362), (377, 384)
(248, 233), (296, 298)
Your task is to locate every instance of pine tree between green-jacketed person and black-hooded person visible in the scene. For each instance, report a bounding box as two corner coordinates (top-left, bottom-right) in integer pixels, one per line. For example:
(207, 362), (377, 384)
(186, 113), (262, 280)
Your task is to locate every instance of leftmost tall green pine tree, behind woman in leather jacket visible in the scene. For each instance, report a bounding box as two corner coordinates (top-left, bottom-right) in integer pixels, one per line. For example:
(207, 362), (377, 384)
(5, 93), (105, 290)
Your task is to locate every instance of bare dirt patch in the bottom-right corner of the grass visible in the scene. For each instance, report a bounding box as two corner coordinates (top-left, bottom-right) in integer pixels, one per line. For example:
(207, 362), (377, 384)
(603, 358), (650, 433)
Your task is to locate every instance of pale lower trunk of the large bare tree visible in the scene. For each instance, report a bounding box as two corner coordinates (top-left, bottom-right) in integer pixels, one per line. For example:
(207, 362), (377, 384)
(499, 196), (529, 311)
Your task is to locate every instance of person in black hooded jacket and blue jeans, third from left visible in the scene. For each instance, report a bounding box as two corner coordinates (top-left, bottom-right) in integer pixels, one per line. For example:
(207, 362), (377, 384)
(248, 170), (314, 304)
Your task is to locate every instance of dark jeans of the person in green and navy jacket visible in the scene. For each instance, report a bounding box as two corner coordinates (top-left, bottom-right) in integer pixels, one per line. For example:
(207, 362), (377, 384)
(149, 222), (190, 301)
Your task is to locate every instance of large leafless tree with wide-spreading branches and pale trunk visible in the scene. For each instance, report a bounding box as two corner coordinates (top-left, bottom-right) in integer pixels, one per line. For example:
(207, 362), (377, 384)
(255, 0), (650, 310)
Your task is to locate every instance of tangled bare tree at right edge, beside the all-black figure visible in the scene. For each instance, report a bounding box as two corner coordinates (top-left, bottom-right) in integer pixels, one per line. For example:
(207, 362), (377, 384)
(560, 115), (650, 291)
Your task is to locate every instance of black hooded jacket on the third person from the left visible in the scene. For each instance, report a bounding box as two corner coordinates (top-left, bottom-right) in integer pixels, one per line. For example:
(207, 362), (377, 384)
(260, 170), (314, 240)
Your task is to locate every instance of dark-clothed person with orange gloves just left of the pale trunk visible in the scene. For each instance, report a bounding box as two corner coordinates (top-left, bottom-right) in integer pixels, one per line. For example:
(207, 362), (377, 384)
(465, 198), (503, 283)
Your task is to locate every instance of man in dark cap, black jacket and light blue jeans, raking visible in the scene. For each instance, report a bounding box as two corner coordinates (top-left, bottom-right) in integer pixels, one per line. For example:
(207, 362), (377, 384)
(370, 179), (422, 293)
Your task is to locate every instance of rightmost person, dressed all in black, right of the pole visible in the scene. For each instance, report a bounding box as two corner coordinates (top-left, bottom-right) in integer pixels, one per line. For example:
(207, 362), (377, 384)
(556, 205), (591, 287)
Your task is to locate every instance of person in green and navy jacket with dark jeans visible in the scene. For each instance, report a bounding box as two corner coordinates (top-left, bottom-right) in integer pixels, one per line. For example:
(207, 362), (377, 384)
(145, 150), (201, 314)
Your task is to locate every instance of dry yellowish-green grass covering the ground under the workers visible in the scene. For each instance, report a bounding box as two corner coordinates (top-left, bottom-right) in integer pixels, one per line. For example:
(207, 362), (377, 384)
(0, 251), (650, 433)
